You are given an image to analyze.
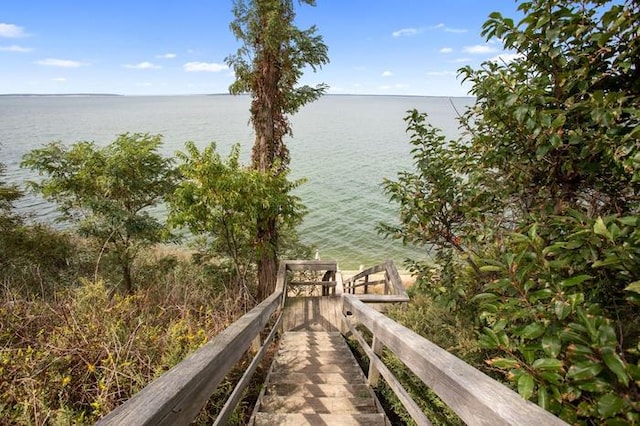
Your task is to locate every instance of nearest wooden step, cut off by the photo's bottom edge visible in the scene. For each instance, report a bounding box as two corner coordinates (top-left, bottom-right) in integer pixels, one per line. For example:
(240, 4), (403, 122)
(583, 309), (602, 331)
(254, 413), (387, 426)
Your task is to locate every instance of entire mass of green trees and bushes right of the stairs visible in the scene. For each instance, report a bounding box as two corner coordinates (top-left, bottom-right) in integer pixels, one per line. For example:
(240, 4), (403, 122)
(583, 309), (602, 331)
(382, 0), (640, 424)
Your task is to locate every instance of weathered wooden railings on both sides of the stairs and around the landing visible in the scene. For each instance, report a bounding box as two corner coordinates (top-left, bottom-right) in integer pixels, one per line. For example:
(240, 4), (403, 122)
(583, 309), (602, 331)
(98, 261), (564, 425)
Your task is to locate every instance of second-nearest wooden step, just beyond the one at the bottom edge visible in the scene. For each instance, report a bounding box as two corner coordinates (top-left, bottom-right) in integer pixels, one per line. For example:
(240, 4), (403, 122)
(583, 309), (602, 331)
(260, 395), (377, 414)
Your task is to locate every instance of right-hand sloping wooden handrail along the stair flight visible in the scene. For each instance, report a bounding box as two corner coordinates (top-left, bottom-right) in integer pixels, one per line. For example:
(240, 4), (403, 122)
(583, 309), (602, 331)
(342, 294), (566, 425)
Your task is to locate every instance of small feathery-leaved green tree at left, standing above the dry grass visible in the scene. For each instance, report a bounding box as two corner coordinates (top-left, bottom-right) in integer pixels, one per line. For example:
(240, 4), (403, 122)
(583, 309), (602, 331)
(23, 133), (175, 292)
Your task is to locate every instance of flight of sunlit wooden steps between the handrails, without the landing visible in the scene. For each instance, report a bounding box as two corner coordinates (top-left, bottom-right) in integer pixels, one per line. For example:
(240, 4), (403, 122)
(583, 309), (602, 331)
(249, 331), (390, 426)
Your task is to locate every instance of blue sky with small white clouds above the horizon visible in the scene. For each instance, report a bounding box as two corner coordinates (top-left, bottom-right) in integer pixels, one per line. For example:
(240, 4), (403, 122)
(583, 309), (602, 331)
(0, 0), (518, 96)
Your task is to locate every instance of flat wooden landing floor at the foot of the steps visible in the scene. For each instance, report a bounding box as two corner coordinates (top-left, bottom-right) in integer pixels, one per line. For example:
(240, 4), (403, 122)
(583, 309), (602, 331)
(282, 296), (342, 331)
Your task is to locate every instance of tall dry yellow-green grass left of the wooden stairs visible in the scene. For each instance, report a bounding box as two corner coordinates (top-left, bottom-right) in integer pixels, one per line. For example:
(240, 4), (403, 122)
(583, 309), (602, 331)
(0, 238), (251, 425)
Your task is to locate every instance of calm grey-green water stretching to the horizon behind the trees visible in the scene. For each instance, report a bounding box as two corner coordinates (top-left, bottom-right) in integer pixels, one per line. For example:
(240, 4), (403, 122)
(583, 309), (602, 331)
(0, 95), (472, 269)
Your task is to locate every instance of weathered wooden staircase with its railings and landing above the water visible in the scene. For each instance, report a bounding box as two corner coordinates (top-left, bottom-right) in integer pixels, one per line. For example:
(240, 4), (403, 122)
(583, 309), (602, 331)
(95, 260), (567, 426)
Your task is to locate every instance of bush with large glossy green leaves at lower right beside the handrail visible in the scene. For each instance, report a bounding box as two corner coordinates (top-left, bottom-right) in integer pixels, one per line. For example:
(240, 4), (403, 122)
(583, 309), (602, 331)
(474, 218), (640, 422)
